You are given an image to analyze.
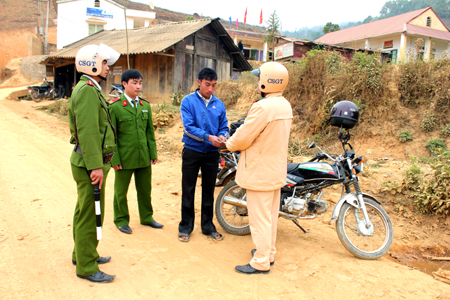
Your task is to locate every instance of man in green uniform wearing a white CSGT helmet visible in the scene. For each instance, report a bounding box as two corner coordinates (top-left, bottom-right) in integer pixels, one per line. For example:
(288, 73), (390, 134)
(69, 44), (120, 282)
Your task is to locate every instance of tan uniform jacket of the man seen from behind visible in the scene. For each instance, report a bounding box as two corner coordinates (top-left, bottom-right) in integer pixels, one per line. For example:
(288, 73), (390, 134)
(227, 93), (292, 191)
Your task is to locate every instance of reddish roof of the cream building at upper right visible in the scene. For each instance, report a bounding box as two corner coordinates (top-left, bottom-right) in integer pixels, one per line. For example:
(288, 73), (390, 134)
(315, 7), (448, 44)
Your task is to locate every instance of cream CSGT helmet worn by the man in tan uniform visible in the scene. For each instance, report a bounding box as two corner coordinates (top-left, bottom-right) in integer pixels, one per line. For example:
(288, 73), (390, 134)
(252, 62), (289, 94)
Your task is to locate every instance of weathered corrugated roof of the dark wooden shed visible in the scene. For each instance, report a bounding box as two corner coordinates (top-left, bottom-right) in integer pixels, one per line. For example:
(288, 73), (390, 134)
(41, 18), (252, 71)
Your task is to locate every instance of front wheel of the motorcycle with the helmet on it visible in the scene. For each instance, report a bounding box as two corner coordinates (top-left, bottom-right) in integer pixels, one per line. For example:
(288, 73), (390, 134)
(336, 197), (393, 259)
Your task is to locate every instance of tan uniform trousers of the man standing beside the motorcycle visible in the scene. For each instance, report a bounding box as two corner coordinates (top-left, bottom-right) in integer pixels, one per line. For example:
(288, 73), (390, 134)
(247, 189), (281, 271)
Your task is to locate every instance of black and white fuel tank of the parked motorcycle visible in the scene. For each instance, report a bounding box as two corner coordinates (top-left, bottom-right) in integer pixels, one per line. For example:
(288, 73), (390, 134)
(289, 162), (339, 181)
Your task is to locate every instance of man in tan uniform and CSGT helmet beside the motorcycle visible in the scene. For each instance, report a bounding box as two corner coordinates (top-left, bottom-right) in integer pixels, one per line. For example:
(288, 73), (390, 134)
(226, 62), (292, 274)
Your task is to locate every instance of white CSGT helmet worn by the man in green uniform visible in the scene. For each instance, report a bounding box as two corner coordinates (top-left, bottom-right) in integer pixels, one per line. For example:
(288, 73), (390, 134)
(75, 44), (120, 76)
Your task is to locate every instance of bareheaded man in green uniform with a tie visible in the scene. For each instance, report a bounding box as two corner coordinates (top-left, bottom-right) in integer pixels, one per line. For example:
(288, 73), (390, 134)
(110, 69), (164, 234)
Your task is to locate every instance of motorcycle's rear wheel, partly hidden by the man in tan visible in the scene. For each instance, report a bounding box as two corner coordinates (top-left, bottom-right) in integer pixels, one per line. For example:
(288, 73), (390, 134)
(216, 181), (250, 235)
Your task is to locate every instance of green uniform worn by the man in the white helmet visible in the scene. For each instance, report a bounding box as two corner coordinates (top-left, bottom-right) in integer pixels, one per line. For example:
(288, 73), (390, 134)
(69, 76), (116, 276)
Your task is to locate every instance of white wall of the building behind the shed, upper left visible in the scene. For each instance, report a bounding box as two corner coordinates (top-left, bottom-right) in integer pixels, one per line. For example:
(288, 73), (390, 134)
(57, 0), (156, 49)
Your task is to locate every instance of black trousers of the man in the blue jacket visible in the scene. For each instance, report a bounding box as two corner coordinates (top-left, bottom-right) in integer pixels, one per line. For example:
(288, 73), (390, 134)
(178, 148), (219, 234)
